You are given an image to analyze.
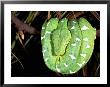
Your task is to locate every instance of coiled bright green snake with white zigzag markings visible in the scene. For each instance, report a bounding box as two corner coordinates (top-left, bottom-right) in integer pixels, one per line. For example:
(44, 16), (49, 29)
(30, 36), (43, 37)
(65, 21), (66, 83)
(41, 17), (96, 74)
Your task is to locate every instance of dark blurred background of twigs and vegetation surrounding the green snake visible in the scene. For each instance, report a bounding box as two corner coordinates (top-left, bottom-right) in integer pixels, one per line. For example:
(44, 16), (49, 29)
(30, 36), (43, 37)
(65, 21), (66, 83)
(11, 11), (100, 77)
